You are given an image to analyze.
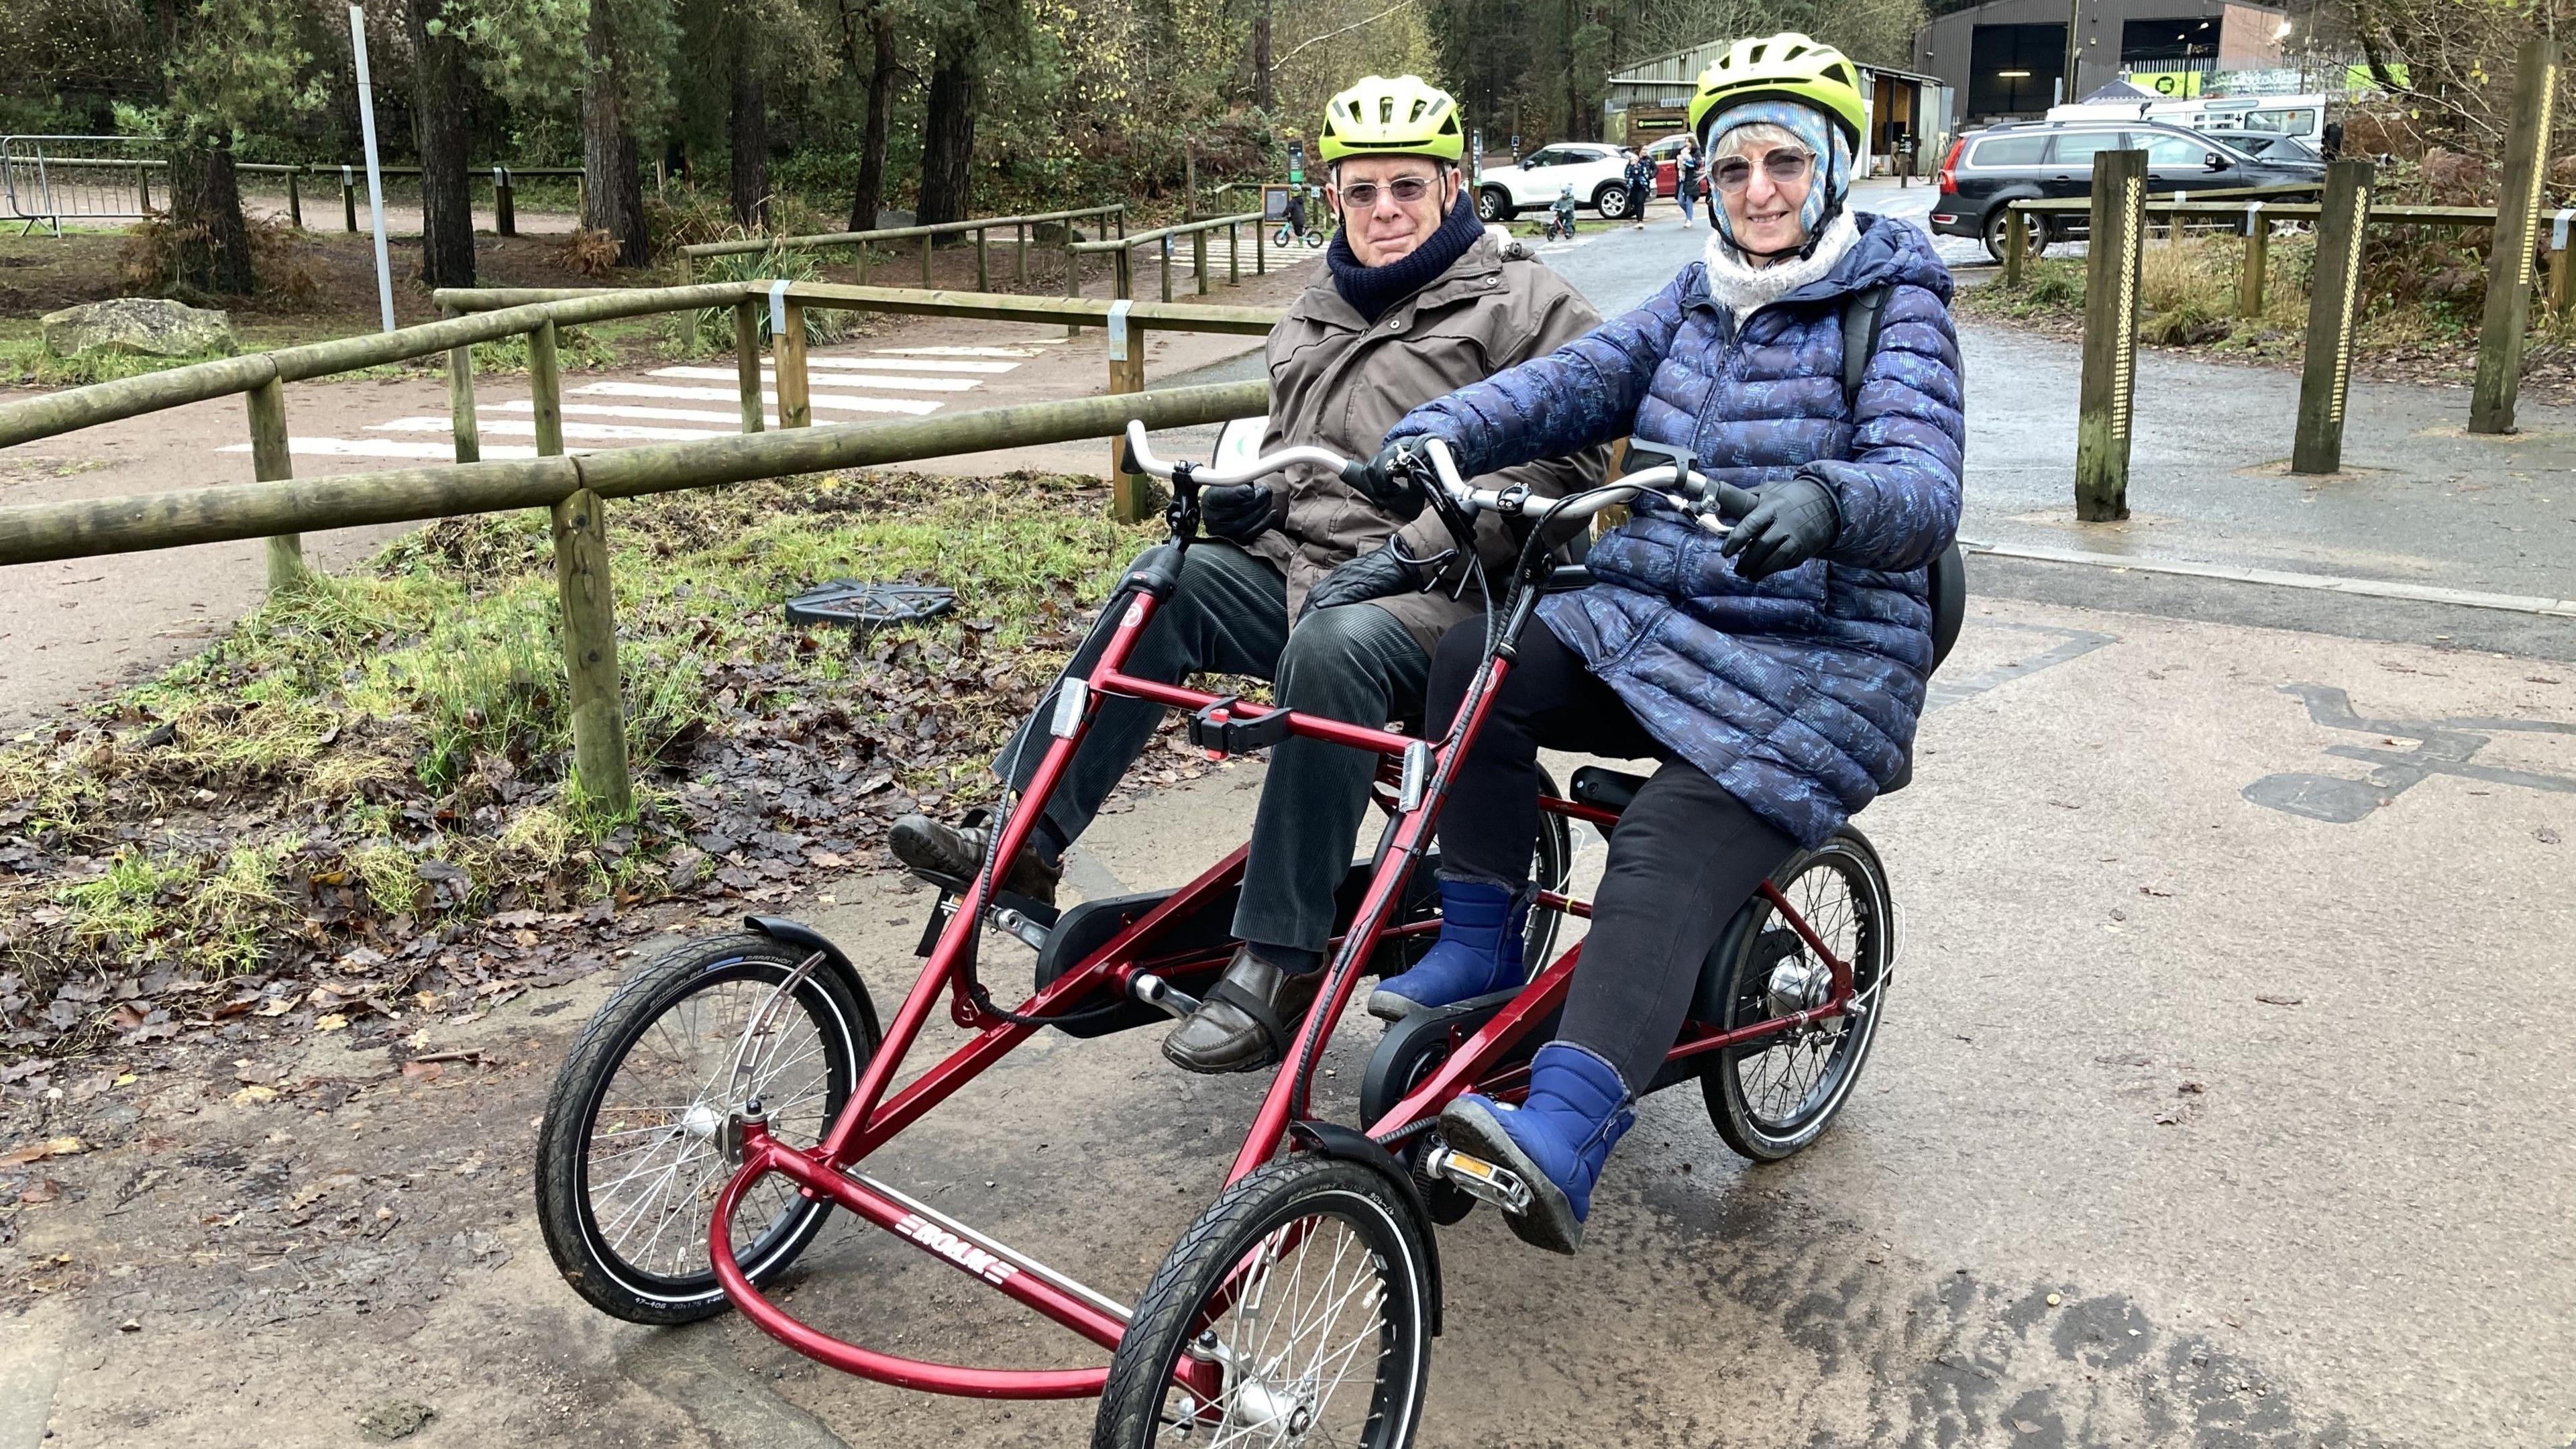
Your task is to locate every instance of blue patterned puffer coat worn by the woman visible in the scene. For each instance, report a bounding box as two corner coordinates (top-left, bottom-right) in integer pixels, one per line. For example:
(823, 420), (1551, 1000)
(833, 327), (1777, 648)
(1389, 214), (1966, 846)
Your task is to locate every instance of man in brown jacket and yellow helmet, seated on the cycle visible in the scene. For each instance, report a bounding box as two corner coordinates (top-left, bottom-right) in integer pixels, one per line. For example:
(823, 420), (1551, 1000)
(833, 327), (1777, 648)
(892, 74), (1602, 1073)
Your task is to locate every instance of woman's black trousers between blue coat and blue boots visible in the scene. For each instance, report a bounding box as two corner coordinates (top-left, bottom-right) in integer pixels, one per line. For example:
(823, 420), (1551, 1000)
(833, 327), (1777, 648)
(1432, 619), (1798, 1091)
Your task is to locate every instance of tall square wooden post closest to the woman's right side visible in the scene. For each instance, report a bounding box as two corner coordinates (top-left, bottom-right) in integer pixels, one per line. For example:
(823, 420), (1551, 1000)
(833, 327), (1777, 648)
(2071, 150), (2146, 523)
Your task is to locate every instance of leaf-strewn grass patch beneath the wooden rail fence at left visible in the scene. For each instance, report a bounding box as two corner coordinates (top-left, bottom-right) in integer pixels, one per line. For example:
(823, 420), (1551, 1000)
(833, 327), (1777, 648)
(0, 474), (1149, 1000)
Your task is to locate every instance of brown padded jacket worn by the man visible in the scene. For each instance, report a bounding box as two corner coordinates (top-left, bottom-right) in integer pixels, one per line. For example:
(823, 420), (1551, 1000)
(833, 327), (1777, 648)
(1252, 232), (1607, 652)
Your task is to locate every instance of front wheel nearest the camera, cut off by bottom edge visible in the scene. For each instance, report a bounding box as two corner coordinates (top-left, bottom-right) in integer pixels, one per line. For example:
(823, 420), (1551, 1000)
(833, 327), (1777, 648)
(1092, 1158), (1432, 1449)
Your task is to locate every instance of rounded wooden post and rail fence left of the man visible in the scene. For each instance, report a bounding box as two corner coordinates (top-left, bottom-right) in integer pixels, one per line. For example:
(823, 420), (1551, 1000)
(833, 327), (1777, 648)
(0, 281), (1280, 812)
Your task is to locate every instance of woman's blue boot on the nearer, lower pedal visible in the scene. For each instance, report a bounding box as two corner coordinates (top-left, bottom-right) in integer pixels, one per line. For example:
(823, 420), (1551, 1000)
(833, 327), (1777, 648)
(1440, 1042), (1635, 1253)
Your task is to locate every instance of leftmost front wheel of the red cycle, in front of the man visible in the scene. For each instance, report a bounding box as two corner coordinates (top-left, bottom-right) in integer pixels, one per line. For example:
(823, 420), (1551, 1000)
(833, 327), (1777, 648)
(536, 933), (876, 1323)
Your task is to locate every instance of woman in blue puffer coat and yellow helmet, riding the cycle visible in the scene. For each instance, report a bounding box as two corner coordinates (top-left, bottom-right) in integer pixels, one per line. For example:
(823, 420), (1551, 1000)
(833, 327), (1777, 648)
(1355, 36), (1966, 1253)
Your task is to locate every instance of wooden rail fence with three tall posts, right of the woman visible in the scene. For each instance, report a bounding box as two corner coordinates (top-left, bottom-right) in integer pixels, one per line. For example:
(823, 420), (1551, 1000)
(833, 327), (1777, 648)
(2002, 41), (2576, 502)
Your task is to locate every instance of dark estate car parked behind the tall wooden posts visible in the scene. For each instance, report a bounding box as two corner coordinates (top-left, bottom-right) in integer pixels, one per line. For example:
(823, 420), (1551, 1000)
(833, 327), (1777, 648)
(1932, 121), (2326, 260)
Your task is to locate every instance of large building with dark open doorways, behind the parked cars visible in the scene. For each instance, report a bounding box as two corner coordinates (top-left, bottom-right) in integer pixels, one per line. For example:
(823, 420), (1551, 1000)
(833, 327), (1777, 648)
(1914, 0), (2290, 129)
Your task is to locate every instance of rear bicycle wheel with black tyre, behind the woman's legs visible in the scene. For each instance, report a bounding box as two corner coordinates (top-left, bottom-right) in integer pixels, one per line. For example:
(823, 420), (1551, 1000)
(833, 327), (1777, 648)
(1700, 828), (1896, 1163)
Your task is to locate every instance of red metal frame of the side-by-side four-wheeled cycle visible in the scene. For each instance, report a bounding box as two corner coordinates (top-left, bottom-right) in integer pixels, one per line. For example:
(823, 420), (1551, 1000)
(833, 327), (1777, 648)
(708, 554), (1852, 1403)
